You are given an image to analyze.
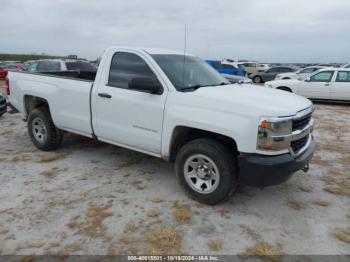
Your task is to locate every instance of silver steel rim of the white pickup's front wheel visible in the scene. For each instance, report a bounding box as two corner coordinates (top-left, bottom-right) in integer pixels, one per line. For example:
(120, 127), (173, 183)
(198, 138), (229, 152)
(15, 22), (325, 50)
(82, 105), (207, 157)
(184, 154), (220, 194)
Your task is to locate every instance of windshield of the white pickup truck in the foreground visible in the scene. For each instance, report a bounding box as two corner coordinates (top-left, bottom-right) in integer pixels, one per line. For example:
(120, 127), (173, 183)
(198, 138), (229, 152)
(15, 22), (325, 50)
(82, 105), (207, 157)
(152, 55), (229, 91)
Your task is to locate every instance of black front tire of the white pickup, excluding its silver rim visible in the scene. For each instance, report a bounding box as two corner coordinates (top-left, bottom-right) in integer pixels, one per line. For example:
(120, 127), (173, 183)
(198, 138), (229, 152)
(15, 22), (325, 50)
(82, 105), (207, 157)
(175, 138), (238, 205)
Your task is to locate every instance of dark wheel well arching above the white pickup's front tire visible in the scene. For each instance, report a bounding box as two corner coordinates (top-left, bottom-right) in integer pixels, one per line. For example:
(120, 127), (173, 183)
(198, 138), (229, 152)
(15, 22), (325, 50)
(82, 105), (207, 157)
(169, 126), (238, 162)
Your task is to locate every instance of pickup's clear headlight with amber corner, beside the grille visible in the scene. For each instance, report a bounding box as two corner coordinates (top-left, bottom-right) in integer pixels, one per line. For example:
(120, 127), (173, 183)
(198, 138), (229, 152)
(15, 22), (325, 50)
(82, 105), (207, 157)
(257, 118), (292, 151)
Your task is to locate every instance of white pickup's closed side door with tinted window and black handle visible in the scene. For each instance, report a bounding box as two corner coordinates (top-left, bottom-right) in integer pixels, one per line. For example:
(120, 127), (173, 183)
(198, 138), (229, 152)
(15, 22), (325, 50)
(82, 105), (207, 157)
(93, 51), (167, 154)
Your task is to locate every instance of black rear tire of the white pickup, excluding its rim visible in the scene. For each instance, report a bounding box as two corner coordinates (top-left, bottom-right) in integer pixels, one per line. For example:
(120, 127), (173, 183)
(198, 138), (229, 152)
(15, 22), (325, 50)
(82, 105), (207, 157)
(28, 107), (63, 151)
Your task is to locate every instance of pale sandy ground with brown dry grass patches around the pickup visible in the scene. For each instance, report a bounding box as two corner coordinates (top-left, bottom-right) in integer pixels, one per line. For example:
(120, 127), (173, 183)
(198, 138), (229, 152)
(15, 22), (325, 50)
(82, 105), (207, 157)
(0, 82), (350, 256)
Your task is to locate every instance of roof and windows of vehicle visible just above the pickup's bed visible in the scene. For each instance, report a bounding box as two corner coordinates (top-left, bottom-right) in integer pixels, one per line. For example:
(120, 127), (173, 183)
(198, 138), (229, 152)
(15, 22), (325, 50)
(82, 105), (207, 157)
(27, 59), (97, 72)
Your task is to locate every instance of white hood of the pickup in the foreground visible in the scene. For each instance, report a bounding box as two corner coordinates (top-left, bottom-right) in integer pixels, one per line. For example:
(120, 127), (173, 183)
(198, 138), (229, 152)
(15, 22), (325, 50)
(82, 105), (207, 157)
(186, 84), (312, 116)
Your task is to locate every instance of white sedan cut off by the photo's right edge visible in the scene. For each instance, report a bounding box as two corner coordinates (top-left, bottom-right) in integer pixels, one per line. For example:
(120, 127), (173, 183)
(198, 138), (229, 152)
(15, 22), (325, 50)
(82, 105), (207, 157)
(265, 68), (350, 101)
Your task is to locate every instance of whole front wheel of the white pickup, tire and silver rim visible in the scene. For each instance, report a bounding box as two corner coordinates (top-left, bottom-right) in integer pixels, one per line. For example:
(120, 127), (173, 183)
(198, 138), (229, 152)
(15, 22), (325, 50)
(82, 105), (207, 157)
(175, 139), (238, 205)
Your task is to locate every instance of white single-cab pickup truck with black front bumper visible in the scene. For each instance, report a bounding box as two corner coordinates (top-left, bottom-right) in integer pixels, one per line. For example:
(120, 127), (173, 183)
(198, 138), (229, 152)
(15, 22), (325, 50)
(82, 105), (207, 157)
(7, 47), (315, 204)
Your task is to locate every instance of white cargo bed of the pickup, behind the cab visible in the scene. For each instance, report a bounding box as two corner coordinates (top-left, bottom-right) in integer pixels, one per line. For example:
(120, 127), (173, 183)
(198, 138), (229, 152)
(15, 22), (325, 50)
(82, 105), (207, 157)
(9, 71), (94, 136)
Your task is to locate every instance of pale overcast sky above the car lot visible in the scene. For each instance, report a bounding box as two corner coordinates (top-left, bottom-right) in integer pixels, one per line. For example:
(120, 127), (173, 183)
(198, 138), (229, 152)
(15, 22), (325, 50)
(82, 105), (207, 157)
(0, 0), (350, 63)
